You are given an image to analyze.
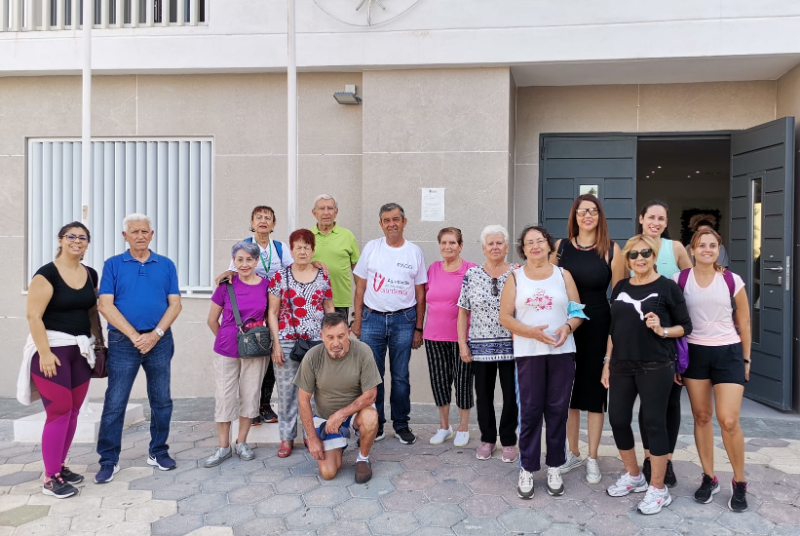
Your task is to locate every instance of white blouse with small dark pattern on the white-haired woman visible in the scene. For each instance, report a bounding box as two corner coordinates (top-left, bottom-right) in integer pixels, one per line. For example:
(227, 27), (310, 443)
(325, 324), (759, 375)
(458, 266), (514, 362)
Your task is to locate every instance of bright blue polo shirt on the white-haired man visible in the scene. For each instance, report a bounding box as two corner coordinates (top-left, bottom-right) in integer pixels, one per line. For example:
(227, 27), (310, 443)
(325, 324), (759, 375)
(98, 250), (181, 331)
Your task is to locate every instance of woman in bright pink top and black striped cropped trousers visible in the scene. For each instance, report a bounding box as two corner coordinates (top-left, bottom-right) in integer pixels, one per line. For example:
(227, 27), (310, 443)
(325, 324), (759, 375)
(422, 227), (477, 447)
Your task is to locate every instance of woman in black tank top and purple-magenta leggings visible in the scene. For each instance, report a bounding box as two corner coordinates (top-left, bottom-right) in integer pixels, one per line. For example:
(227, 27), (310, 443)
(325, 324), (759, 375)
(17, 221), (102, 499)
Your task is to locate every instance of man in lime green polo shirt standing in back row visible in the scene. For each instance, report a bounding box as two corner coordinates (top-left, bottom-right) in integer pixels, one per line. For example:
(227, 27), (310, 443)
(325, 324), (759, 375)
(311, 194), (359, 322)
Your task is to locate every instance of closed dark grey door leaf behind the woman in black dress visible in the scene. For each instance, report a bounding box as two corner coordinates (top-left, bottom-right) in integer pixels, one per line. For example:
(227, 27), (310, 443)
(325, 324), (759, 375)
(539, 136), (636, 246)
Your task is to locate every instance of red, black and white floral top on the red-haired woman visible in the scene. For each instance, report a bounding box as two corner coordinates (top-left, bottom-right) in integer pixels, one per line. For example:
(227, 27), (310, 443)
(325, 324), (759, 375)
(269, 267), (333, 341)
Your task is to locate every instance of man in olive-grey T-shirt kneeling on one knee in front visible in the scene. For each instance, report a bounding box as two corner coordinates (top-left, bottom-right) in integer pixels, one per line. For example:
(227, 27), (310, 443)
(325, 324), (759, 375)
(294, 312), (381, 484)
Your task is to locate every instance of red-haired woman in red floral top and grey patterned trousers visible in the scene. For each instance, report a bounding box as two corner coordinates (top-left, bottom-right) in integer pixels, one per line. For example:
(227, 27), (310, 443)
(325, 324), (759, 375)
(268, 229), (334, 458)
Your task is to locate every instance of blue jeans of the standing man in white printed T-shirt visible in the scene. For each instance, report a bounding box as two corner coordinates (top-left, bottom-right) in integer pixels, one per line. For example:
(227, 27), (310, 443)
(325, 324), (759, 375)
(361, 307), (417, 431)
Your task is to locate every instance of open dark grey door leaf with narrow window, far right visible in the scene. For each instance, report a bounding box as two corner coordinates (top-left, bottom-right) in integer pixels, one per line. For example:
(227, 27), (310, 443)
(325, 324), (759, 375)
(730, 117), (794, 409)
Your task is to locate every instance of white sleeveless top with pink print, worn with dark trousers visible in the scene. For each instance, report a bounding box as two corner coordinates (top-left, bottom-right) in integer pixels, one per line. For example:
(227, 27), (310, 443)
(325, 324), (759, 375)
(514, 265), (575, 357)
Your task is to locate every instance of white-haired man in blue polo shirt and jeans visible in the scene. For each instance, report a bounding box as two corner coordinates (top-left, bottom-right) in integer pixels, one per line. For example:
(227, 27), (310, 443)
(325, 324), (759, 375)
(95, 214), (181, 484)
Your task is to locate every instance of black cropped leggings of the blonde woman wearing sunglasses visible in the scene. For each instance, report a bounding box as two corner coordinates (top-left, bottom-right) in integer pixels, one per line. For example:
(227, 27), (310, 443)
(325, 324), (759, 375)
(608, 361), (675, 456)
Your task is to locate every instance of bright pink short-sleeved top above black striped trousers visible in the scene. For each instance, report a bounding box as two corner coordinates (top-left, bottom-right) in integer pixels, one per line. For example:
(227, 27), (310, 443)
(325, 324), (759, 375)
(422, 261), (477, 342)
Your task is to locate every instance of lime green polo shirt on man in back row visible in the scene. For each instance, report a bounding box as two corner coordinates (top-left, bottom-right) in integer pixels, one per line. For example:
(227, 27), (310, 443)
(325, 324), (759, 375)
(311, 222), (360, 307)
